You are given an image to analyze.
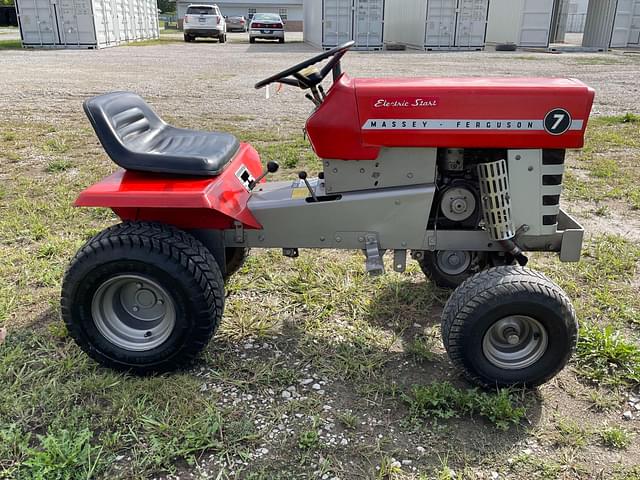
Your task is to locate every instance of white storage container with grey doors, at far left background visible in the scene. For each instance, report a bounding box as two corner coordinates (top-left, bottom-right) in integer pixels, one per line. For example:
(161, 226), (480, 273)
(16, 0), (160, 48)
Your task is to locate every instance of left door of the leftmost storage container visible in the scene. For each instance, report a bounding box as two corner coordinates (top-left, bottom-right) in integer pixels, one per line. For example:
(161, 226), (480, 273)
(17, 0), (58, 45)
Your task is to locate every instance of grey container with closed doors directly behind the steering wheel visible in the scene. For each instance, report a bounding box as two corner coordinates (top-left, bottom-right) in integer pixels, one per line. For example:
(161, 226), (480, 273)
(303, 0), (390, 50)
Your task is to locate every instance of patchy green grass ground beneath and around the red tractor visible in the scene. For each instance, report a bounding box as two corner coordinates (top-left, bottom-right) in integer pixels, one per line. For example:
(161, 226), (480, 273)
(0, 116), (640, 480)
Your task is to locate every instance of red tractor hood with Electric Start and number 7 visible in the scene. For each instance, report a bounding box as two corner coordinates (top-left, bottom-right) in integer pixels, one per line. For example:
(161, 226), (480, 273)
(307, 75), (594, 160)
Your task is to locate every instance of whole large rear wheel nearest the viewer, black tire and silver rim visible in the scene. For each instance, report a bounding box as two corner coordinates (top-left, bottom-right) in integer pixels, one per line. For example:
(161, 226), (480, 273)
(61, 222), (224, 373)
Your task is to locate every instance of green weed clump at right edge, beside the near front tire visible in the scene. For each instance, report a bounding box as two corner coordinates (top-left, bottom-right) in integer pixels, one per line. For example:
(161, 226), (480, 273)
(576, 325), (640, 385)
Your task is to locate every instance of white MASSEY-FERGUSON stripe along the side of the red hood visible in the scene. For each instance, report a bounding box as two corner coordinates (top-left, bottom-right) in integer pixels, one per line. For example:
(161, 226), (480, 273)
(362, 119), (583, 135)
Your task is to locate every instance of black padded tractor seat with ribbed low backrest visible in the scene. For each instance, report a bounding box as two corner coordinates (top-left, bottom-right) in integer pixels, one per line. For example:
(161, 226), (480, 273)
(84, 92), (240, 176)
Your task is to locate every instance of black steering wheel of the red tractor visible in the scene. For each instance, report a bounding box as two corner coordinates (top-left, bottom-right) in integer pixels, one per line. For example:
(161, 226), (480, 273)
(255, 40), (356, 90)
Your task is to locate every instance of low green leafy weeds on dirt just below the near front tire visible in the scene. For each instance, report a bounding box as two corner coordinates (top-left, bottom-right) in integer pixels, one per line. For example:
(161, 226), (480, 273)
(402, 381), (526, 430)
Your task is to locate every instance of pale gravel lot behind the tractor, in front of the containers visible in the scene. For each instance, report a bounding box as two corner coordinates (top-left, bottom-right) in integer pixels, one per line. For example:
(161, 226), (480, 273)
(0, 34), (640, 129)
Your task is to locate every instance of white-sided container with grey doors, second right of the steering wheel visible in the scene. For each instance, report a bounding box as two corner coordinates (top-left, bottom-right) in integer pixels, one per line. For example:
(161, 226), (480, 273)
(385, 0), (489, 50)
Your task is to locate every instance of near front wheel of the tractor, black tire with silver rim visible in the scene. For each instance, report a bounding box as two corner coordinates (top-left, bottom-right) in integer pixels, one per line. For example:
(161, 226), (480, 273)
(442, 266), (578, 388)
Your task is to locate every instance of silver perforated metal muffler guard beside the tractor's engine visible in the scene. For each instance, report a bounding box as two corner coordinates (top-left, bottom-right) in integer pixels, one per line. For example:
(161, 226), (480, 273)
(478, 160), (515, 241)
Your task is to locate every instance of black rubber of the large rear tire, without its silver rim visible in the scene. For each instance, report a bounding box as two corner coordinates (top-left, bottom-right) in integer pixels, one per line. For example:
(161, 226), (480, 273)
(61, 222), (224, 374)
